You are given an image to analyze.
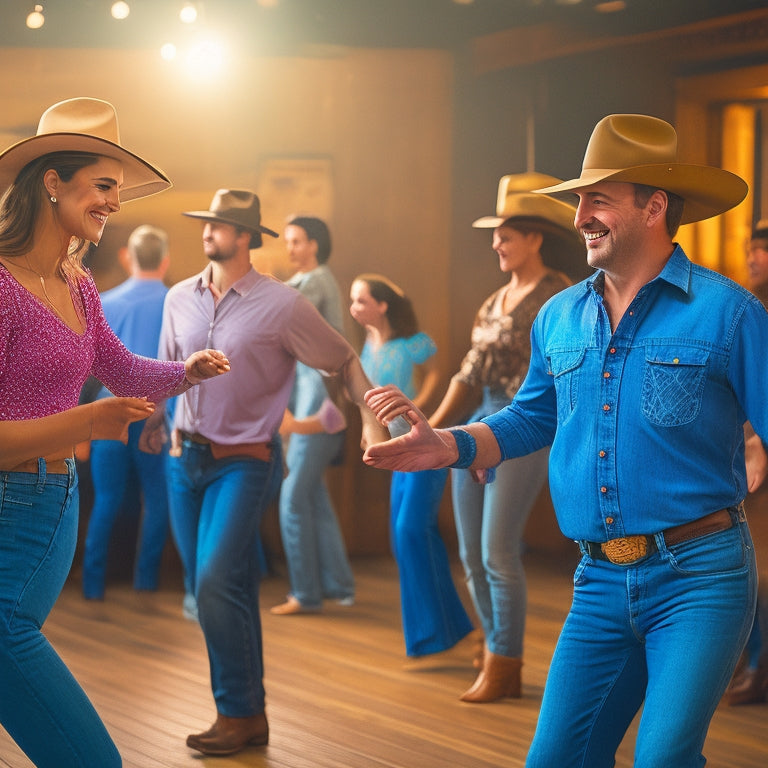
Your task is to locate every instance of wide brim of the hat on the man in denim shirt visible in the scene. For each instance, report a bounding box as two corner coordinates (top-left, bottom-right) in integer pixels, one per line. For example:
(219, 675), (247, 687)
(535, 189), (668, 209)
(534, 163), (749, 224)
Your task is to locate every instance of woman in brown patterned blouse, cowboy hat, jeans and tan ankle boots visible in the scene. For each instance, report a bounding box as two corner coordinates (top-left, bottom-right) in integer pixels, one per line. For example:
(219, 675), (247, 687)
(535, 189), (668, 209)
(430, 173), (584, 702)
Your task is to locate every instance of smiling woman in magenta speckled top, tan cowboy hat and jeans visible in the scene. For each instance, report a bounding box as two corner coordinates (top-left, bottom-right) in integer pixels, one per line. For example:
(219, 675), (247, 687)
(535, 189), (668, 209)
(0, 98), (229, 768)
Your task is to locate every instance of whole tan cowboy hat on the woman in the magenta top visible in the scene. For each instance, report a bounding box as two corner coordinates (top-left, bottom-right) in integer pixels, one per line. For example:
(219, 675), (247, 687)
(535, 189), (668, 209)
(0, 98), (171, 202)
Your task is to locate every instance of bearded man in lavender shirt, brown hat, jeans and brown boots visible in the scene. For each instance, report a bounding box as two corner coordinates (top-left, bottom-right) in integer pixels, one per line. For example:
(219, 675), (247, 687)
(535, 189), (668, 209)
(144, 189), (388, 755)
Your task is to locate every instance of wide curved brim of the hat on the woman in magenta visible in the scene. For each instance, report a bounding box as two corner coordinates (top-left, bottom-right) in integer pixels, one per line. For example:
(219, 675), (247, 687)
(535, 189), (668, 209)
(0, 132), (173, 203)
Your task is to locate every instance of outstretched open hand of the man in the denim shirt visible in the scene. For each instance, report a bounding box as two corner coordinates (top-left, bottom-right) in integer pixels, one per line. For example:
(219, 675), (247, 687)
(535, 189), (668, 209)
(363, 385), (459, 472)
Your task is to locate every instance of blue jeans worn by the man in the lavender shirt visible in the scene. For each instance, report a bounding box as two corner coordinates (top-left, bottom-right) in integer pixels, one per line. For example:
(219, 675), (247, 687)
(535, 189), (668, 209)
(168, 440), (283, 717)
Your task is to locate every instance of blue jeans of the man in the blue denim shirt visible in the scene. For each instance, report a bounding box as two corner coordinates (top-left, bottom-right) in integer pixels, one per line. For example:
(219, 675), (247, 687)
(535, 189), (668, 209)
(526, 514), (757, 768)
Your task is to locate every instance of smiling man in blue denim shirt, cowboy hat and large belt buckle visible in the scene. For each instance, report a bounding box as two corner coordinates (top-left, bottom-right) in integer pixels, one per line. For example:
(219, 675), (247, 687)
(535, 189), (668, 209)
(365, 115), (768, 768)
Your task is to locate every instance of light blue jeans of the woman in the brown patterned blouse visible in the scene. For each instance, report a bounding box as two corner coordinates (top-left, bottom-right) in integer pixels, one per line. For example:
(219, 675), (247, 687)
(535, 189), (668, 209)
(452, 392), (549, 658)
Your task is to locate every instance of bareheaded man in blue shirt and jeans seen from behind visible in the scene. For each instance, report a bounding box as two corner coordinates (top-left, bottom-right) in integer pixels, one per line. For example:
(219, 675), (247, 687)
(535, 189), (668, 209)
(83, 225), (175, 600)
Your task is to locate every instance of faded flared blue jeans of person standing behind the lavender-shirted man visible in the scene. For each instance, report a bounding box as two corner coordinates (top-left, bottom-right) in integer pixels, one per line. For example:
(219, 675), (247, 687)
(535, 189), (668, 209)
(280, 434), (355, 608)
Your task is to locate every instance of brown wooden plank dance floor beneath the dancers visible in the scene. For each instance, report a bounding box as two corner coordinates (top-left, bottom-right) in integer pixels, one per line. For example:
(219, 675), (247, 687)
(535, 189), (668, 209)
(0, 555), (768, 768)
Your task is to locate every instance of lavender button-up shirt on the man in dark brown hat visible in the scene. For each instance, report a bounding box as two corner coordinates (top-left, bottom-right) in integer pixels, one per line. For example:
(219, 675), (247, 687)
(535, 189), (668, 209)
(158, 265), (354, 445)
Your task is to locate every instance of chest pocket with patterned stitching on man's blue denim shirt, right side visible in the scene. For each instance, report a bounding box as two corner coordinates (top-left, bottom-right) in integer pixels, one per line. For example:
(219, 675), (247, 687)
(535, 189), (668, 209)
(641, 344), (709, 427)
